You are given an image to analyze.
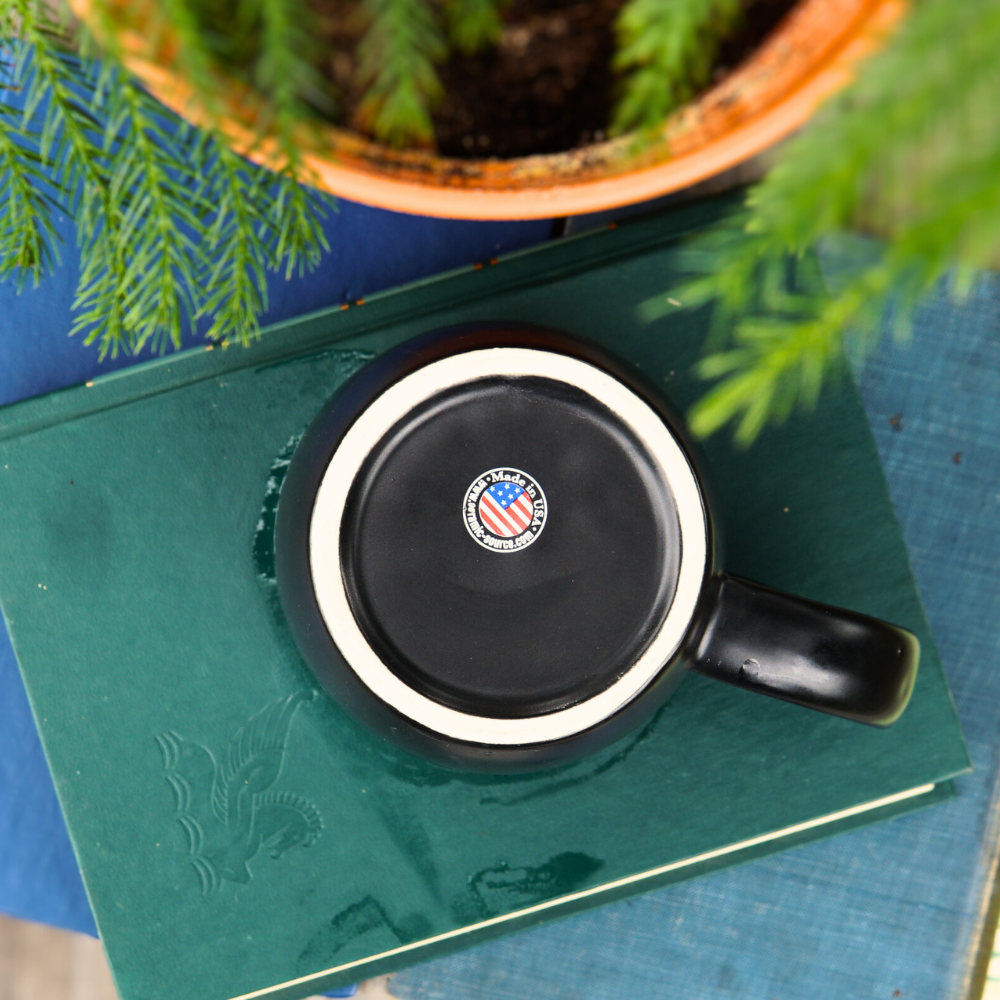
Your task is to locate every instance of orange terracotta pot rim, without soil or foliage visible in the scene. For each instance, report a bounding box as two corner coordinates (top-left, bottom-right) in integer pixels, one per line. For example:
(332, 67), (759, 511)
(73, 0), (904, 219)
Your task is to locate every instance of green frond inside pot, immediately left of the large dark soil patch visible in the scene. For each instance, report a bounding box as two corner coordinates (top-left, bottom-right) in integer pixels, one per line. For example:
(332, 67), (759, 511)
(358, 0), (447, 146)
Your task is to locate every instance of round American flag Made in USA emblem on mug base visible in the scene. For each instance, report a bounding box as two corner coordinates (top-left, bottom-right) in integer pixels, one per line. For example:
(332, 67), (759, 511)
(462, 469), (548, 552)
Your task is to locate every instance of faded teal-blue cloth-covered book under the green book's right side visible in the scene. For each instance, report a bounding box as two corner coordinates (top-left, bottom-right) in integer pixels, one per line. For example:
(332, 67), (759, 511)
(390, 276), (1000, 1000)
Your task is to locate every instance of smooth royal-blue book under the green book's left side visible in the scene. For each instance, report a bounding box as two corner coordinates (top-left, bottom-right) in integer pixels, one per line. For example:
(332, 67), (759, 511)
(0, 197), (551, 934)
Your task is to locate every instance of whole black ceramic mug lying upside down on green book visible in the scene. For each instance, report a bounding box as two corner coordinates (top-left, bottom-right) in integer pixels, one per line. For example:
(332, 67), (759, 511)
(275, 324), (919, 771)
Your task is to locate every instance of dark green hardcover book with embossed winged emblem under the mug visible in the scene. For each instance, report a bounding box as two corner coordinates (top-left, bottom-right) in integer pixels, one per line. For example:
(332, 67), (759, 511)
(0, 197), (969, 1000)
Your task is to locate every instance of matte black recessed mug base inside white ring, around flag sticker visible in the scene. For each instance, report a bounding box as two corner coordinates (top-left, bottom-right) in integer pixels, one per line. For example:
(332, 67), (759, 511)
(341, 379), (680, 718)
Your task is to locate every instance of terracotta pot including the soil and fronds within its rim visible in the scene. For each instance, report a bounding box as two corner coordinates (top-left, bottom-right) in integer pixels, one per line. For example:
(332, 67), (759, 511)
(73, 0), (901, 219)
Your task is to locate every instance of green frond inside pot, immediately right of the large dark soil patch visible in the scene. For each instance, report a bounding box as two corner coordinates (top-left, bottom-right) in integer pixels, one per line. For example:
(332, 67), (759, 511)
(611, 0), (742, 134)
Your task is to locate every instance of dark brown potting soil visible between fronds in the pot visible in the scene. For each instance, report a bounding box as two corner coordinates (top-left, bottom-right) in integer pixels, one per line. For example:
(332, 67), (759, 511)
(313, 0), (796, 159)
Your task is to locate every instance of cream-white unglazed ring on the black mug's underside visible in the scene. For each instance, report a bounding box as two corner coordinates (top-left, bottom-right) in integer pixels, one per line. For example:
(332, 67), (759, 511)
(309, 347), (708, 746)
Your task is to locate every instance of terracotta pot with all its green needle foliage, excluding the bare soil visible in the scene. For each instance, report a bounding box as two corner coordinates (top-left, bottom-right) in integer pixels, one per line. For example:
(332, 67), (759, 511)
(25, 0), (984, 418)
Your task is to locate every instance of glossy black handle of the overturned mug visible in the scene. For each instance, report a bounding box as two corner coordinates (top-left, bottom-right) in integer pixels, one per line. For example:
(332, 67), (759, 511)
(689, 573), (920, 726)
